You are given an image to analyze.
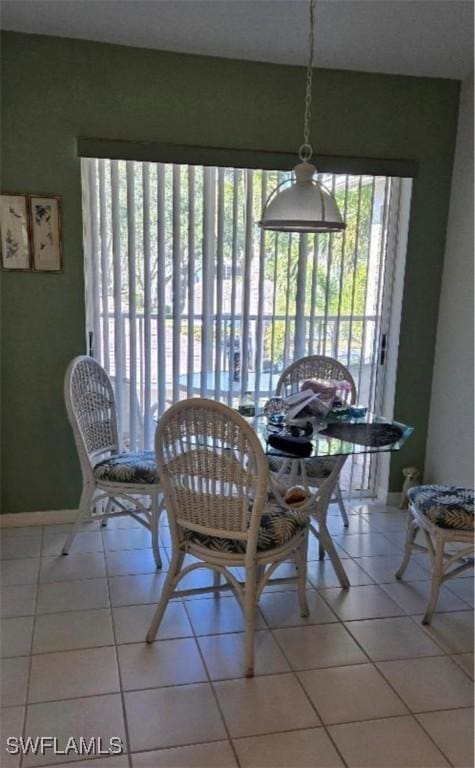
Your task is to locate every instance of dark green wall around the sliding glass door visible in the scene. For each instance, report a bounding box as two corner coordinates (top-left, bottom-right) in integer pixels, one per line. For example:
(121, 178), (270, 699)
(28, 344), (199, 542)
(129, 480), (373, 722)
(1, 33), (459, 512)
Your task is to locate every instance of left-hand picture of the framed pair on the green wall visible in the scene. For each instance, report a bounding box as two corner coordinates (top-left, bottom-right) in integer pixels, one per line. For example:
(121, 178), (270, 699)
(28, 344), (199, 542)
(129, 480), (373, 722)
(0, 195), (31, 270)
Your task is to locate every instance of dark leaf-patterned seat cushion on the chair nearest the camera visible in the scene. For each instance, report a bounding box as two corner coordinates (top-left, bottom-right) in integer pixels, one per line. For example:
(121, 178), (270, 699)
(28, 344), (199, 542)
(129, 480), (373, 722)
(186, 501), (309, 554)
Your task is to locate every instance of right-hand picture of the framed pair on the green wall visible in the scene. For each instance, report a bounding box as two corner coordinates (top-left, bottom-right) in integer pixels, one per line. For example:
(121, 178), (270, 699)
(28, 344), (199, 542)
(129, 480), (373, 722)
(29, 195), (62, 272)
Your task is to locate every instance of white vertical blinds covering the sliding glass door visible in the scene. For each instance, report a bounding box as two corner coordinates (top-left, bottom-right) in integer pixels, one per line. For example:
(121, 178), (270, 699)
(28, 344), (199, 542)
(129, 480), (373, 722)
(82, 159), (398, 496)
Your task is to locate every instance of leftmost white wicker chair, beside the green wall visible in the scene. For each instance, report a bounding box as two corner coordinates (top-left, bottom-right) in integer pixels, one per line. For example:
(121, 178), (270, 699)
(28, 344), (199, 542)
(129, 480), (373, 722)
(63, 356), (162, 568)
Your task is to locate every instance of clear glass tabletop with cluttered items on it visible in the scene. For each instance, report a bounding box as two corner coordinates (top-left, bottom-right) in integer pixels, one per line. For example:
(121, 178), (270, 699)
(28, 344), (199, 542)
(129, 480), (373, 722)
(251, 413), (414, 459)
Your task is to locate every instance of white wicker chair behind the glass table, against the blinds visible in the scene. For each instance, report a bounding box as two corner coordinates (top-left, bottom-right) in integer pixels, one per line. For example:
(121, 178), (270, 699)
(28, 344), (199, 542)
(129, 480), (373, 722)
(271, 355), (356, 527)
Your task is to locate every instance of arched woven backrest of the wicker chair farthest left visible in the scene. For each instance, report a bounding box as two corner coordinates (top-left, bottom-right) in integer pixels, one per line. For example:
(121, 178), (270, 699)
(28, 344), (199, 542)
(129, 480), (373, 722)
(64, 355), (119, 472)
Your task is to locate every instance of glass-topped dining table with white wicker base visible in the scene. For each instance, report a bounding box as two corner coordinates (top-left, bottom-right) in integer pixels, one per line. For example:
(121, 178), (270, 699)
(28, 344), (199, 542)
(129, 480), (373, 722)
(246, 408), (414, 589)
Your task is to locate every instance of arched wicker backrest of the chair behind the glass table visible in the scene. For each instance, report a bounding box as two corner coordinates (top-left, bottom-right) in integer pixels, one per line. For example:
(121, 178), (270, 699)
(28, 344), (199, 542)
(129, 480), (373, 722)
(276, 355), (356, 405)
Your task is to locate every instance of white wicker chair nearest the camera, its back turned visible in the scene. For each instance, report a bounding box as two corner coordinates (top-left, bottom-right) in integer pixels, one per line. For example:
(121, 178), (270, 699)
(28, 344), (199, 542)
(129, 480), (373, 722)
(147, 398), (309, 677)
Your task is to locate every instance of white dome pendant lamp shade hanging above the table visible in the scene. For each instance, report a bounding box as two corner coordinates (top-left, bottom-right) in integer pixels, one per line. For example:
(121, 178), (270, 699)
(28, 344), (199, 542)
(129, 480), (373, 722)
(259, 162), (346, 232)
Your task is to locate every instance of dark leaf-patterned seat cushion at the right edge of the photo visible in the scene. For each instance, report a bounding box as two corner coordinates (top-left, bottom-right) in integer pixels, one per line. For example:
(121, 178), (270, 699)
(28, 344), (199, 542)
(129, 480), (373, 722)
(407, 485), (474, 531)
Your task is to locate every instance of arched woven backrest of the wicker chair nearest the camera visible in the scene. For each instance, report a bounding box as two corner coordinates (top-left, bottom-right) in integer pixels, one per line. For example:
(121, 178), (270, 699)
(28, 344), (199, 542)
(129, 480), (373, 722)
(155, 398), (269, 553)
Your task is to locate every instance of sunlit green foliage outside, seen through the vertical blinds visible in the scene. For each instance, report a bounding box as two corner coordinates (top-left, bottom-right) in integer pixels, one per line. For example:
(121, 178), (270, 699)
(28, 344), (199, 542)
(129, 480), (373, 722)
(97, 160), (380, 365)
